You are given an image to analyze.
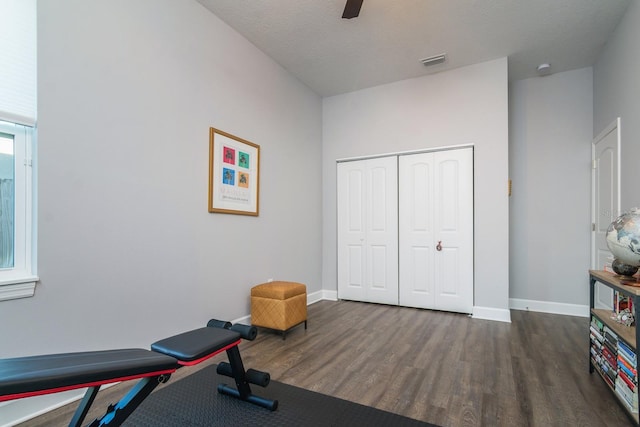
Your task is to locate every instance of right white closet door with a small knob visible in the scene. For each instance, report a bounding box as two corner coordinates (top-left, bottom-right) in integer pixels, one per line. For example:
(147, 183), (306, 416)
(398, 148), (473, 313)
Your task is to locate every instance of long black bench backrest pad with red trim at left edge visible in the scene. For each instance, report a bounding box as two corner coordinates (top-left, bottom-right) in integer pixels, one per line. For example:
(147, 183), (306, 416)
(0, 349), (179, 401)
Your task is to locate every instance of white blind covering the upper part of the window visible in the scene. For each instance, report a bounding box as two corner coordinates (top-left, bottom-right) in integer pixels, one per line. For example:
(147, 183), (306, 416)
(0, 0), (37, 126)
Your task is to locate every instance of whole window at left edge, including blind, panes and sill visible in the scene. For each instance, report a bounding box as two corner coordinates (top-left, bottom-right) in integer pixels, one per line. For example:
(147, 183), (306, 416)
(0, 0), (38, 301)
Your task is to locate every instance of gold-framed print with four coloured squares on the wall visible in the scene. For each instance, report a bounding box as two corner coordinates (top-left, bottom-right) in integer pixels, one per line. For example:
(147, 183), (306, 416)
(209, 128), (260, 216)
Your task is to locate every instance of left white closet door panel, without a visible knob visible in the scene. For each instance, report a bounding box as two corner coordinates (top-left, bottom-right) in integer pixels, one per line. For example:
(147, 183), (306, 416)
(337, 156), (398, 304)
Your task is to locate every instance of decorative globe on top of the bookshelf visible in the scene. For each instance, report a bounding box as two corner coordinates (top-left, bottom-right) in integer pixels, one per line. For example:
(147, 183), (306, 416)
(606, 208), (640, 267)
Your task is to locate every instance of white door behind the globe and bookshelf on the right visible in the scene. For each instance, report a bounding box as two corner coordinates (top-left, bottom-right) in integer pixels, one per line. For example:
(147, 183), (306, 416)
(591, 118), (620, 309)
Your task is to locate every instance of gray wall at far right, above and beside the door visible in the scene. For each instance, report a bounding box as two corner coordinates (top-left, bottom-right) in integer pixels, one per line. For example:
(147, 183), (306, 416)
(593, 1), (640, 211)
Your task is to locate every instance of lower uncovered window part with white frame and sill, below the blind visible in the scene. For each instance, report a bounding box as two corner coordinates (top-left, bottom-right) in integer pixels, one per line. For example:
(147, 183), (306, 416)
(0, 122), (37, 300)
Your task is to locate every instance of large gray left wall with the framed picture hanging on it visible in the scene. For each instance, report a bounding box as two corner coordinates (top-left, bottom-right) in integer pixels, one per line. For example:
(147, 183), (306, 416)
(0, 0), (322, 357)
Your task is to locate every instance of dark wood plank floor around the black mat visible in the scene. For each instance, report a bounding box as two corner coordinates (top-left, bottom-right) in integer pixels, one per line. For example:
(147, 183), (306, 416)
(21, 301), (632, 427)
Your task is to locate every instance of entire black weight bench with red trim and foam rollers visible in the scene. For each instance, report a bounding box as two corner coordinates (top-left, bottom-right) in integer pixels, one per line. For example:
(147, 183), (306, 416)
(0, 319), (278, 427)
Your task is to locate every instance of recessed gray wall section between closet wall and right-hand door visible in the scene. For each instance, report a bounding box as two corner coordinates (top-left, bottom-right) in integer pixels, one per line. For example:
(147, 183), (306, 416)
(509, 67), (593, 314)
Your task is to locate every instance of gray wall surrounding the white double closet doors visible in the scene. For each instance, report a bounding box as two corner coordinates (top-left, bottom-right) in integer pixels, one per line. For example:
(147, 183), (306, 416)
(322, 58), (510, 320)
